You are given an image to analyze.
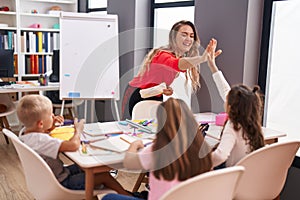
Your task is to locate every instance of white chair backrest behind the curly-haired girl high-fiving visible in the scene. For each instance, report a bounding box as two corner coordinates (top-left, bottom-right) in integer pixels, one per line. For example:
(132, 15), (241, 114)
(234, 141), (300, 200)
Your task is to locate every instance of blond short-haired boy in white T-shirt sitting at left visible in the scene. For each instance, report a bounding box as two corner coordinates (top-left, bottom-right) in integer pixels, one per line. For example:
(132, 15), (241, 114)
(17, 95), (129, 195)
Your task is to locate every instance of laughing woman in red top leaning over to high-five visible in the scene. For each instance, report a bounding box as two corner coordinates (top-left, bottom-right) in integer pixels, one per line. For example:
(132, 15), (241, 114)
(122, 21), (221, 118)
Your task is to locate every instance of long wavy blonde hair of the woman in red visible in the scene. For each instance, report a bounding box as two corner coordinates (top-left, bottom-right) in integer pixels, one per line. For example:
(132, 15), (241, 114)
(138, 20), (200, 92)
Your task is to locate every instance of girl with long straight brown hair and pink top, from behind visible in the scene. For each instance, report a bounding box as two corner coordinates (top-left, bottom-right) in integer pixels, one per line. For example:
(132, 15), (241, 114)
(103, 98), (212, 200)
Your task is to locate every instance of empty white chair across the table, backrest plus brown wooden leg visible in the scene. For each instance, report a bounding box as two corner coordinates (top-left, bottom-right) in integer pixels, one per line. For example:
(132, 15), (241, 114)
(132, 100), (161, 192)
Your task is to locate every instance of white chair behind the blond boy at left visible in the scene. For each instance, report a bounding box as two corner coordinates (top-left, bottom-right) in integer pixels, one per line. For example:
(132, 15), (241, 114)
(3, 129), (85, 200)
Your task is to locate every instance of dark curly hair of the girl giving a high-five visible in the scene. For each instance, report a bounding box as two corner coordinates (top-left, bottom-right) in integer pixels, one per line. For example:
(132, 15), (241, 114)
(227, 85), (265, 151)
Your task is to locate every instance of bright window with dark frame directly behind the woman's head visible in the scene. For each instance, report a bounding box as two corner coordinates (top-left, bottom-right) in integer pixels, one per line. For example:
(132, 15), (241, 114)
(152, 0), (195, 47)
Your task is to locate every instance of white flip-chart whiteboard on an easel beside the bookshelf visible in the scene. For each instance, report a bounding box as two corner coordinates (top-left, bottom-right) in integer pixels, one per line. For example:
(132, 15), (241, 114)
(60, 12), (119, 100)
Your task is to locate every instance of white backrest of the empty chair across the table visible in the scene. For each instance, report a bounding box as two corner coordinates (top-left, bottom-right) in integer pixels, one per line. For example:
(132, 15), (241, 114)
(132, 100), (161, 119)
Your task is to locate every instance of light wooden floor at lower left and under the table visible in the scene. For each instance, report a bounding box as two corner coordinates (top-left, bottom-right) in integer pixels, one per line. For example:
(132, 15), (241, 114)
(0, 132), (144, 200)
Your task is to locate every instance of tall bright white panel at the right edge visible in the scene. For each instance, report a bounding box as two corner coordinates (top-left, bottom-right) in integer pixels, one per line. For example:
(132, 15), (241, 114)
(264, 1), (300, 156)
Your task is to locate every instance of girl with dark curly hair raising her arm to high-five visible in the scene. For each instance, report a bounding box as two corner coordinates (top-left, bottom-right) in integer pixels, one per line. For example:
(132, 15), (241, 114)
(208, 39), (264, 168)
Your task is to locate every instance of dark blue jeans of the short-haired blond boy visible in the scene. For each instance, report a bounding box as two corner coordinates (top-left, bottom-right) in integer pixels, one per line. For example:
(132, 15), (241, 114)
(61, 165), (85, 190)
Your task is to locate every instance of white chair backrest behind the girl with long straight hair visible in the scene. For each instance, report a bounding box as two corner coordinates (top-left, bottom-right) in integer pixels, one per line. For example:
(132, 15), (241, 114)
(160, 166), (244, 200)
